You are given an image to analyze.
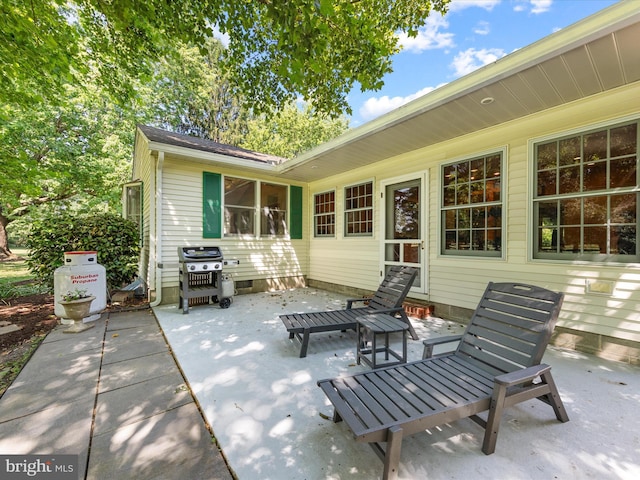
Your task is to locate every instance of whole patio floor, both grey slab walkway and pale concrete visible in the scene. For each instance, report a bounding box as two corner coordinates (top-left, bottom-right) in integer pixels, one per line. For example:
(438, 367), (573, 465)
(0, 289), (640, 480)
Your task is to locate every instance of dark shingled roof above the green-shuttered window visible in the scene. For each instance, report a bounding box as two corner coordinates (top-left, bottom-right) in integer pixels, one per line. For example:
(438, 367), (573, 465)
(138, 125), (287, 165)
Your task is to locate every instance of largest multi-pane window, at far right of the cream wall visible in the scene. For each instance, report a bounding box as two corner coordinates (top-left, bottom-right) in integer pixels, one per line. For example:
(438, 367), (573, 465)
(533, 121), (640, 262)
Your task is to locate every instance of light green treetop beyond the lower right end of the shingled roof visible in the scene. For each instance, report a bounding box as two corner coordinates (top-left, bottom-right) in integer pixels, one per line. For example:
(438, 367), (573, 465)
(239, 103), (349, 158)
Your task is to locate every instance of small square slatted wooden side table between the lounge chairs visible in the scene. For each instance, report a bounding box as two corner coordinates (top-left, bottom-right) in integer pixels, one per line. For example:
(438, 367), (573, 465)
(356, 313), (409, 368)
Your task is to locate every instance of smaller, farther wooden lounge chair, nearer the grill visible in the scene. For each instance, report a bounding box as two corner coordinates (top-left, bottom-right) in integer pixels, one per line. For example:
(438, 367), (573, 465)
(280, 266), (418, 358)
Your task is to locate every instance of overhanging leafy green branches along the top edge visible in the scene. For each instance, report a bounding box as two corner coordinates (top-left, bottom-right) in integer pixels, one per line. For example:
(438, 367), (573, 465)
(0, 0), (450, 116)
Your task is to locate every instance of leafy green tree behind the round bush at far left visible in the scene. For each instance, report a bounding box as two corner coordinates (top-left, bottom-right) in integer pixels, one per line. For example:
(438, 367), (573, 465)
(0, 79), (135, 257)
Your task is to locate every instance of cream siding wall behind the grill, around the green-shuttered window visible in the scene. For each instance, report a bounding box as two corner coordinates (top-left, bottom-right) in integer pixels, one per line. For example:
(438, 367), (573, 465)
(159, 155), (309, 303)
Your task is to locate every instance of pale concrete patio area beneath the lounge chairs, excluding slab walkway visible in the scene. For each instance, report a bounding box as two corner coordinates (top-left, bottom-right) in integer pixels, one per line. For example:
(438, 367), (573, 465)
(154, 289), (640, 480)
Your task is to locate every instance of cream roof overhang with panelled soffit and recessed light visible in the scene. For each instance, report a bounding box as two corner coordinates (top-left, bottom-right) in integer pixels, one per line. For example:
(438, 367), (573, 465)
(275, 1), (640, 182)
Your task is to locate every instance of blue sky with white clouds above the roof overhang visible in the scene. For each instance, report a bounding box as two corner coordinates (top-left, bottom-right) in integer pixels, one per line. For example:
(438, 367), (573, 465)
(348, 0), (624, 127)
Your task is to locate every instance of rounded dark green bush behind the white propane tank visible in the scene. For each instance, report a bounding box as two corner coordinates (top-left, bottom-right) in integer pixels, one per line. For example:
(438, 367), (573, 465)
(27, 212), (140, 290)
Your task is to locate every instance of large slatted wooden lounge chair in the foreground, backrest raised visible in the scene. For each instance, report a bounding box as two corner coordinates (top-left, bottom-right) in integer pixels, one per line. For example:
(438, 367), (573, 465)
(318, 283), (569, 479)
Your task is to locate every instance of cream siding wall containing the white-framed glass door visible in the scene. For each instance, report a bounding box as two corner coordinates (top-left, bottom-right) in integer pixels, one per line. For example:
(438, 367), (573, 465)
(309, 84), (640, 360)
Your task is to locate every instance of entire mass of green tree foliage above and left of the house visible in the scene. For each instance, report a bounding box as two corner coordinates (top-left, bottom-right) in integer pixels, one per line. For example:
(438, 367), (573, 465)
(0, 0), (440, 256)
